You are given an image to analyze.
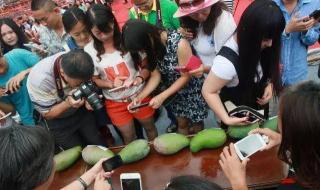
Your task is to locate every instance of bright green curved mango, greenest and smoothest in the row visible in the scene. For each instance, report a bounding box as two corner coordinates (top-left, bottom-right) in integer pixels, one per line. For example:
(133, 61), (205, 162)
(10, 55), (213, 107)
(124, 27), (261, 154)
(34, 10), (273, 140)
(190, 128), (227, 152)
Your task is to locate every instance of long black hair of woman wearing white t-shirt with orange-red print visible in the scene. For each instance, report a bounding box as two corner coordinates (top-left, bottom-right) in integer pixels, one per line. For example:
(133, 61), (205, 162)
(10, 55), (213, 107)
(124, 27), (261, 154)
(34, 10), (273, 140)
(87, 4), (122, 60)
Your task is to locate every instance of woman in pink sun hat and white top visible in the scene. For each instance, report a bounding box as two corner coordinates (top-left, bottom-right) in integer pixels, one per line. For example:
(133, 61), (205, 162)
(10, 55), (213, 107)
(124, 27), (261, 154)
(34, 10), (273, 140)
(174, 0), (236, 76)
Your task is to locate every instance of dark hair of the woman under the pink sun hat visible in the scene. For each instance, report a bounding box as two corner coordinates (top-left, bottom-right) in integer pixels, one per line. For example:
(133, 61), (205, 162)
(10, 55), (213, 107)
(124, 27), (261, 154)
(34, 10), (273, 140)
(177, 1), (228, 35)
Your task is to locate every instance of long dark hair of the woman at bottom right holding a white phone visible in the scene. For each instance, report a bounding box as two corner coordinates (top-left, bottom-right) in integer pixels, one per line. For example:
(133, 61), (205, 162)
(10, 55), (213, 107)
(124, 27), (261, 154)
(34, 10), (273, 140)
(278, 81), (320, 189)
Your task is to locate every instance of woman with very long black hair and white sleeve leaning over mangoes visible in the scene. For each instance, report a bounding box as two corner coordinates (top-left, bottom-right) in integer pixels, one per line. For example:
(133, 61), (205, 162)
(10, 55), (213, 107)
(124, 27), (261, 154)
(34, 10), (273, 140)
(202, 0), (285, 125)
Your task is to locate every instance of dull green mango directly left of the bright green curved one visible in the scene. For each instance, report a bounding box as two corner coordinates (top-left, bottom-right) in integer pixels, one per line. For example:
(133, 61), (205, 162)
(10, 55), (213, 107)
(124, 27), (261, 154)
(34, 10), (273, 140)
(153, 133), (190, 155)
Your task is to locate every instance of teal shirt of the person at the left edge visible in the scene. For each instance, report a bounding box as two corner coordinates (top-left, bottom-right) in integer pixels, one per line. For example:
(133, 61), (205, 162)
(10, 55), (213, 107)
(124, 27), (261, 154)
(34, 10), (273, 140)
(0, 49), (40, 126)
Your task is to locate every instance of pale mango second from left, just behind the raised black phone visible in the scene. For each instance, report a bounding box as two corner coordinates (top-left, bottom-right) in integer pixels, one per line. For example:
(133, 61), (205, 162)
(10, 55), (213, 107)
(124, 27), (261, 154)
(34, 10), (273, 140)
(82, 145), (114, 165)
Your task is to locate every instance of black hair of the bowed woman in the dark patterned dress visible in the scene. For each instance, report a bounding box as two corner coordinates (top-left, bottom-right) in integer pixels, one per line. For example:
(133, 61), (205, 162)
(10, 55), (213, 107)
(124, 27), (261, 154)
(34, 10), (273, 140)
(122, 20), (166, 71)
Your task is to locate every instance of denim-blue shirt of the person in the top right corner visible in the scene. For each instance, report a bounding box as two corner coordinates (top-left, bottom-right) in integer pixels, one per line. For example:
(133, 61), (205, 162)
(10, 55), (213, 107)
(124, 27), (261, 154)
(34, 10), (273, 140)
(274, 0), (320, 86)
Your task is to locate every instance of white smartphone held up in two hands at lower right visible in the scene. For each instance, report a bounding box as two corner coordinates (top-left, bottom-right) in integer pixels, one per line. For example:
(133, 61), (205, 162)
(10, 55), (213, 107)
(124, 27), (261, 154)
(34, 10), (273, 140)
(234, 134), (268, 160)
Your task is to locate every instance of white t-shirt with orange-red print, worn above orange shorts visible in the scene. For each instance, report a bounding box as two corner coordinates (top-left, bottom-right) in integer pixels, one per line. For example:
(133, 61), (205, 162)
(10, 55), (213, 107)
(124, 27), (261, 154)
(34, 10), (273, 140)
(84, 40), (144, 100)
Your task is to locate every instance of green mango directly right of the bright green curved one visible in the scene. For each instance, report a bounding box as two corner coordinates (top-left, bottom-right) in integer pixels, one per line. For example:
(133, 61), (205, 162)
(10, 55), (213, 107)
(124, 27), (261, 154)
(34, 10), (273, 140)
(227, 123), (259, 139)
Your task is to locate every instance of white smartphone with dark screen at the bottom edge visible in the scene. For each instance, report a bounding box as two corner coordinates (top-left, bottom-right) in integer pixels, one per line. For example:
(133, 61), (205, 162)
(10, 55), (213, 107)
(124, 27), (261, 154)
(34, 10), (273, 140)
(120, 173), (142, 190)
